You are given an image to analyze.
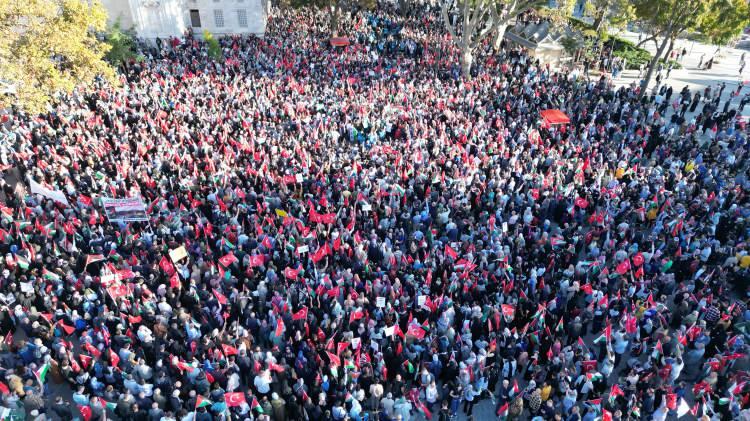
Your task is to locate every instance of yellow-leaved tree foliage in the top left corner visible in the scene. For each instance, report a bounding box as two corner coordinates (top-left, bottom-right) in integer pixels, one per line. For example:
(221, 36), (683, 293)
(0, 0), (115, 113)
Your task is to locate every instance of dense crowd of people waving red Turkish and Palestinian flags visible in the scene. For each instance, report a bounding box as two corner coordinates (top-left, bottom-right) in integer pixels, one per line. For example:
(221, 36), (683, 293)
(0, 5), (750, 421)
